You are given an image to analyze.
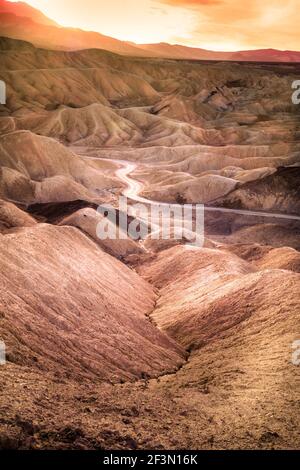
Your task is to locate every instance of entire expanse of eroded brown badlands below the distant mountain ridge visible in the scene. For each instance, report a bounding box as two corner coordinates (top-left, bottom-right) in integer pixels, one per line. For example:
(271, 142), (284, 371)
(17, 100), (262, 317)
(0, 35), (300, 449)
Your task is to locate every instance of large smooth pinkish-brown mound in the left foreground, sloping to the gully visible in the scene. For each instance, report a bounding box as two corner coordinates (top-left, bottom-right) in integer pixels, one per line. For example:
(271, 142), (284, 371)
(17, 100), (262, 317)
(0, 225), (182, 381)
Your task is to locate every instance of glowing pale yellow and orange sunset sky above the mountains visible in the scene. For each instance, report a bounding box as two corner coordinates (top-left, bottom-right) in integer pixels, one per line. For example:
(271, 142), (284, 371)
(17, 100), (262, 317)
(8, 0), (300, 51)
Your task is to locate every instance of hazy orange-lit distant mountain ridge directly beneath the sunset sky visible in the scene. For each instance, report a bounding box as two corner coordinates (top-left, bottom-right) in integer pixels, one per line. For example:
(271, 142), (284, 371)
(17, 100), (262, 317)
(0, 0), (300, 62)
